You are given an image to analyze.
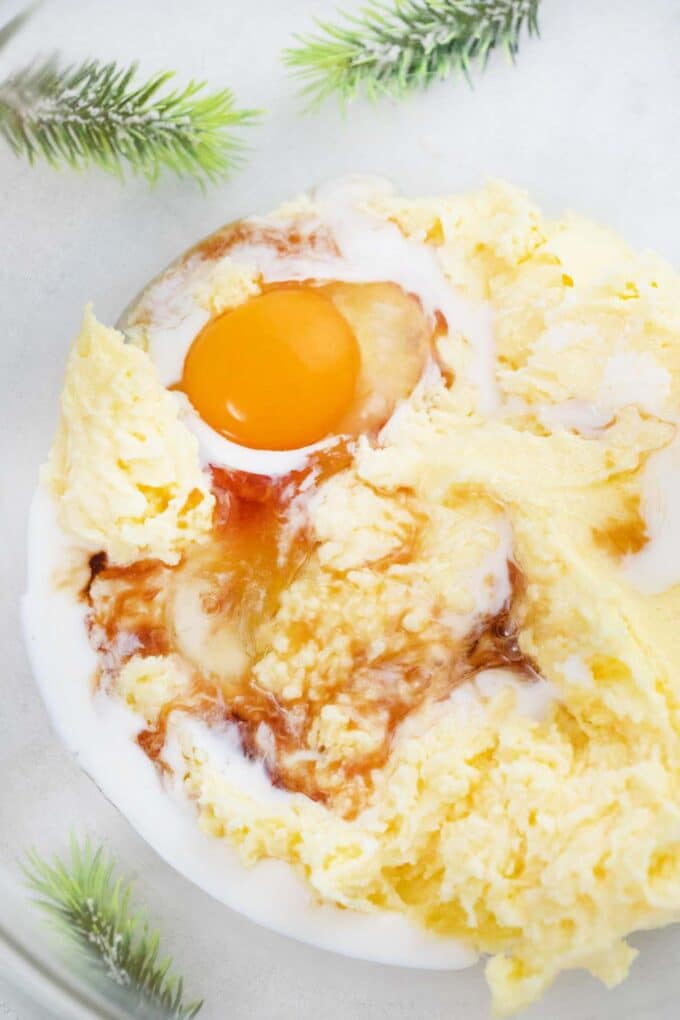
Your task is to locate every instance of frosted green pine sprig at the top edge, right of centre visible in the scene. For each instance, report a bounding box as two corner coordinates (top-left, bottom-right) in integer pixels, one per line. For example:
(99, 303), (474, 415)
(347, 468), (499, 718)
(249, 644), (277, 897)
(283, 0), (540, 105)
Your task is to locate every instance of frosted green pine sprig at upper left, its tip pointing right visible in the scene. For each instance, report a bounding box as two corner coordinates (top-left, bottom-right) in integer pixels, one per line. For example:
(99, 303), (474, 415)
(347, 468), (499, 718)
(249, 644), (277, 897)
(0, 57), (258, 184)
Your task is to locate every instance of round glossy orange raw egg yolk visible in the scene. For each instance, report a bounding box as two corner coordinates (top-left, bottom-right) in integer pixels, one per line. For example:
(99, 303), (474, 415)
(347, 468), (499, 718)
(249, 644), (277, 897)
(180, 287), (361, 450)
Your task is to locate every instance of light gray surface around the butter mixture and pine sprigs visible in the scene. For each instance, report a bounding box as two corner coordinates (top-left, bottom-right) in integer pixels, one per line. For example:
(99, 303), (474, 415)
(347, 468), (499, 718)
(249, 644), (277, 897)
(0, 0), (680, 1020)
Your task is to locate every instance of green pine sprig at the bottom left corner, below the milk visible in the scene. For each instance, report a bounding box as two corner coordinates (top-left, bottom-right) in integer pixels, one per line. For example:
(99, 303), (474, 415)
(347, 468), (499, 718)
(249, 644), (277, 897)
(24, 836), (202, 1020)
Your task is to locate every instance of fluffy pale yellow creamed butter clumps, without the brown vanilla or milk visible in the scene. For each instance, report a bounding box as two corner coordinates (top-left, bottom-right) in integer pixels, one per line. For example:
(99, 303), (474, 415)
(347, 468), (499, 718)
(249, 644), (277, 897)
(48, 184), (680, 1013)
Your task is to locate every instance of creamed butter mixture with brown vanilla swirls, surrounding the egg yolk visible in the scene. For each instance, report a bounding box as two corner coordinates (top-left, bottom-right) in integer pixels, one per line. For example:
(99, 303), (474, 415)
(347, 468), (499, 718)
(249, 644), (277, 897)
(41, 184), (680, 1013)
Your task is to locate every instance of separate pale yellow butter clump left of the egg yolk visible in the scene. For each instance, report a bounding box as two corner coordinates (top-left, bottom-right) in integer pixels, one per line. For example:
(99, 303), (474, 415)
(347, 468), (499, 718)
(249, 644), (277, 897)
(43, 308), (214, 563)
